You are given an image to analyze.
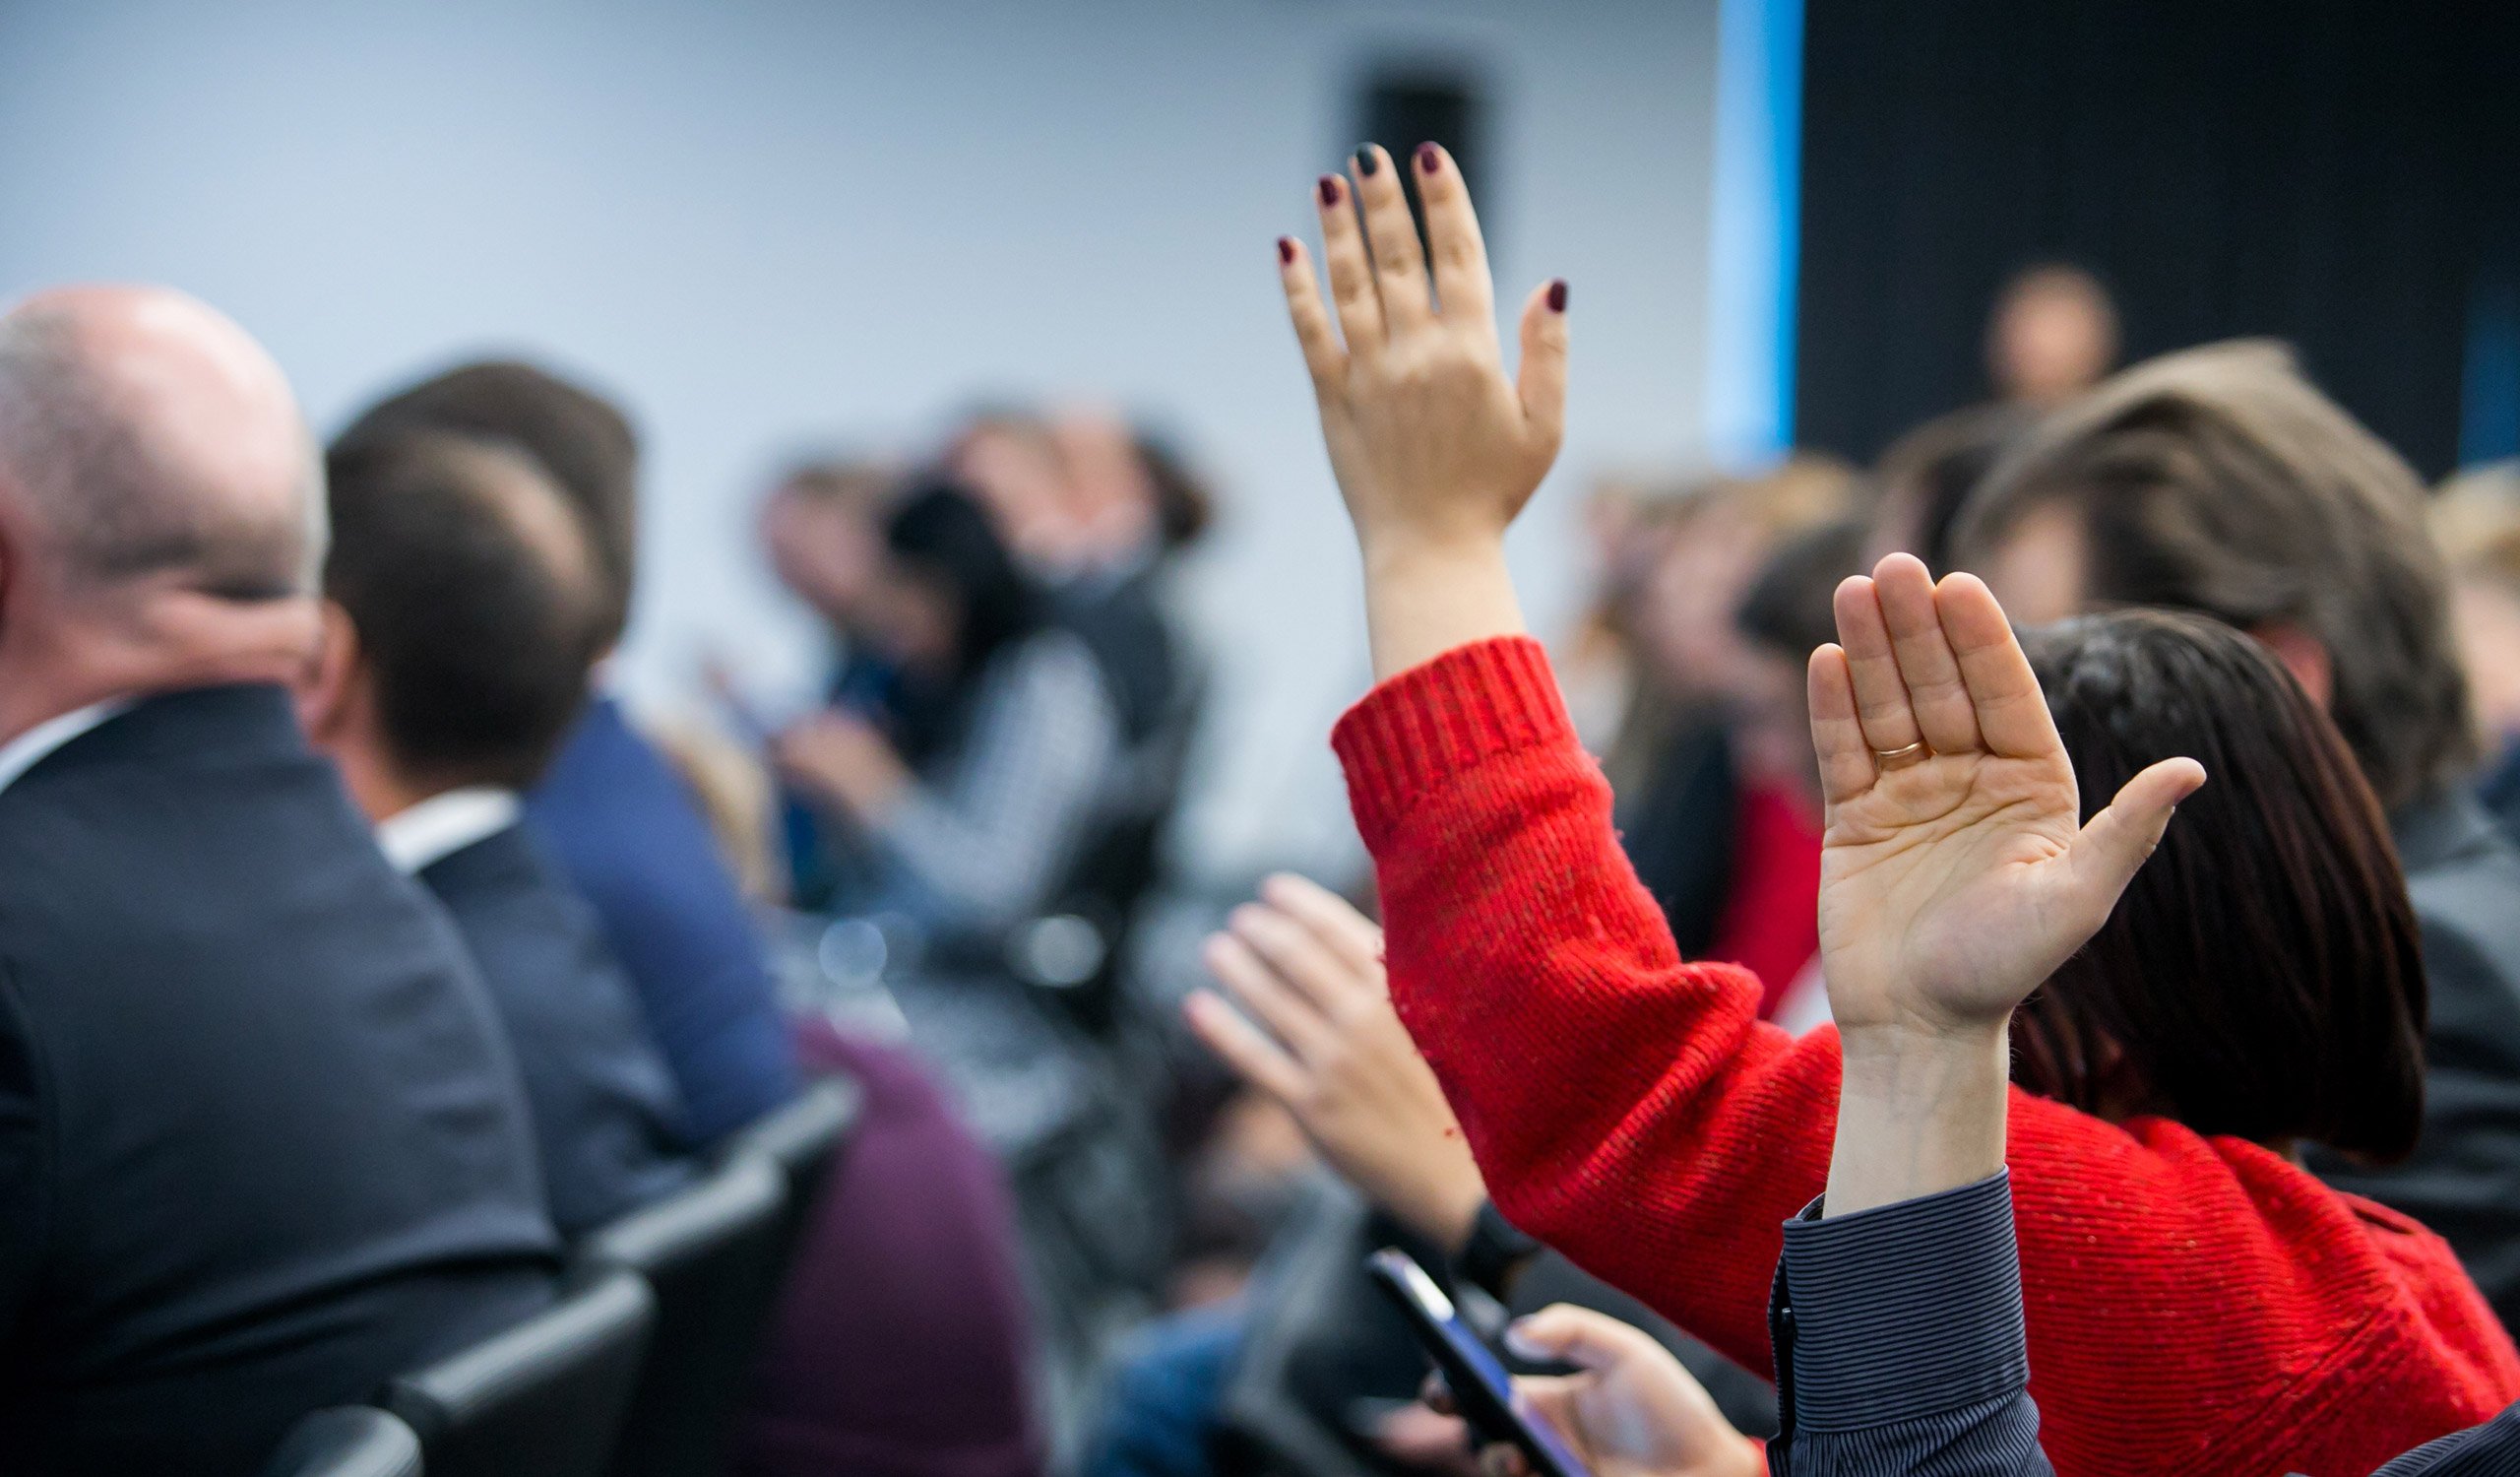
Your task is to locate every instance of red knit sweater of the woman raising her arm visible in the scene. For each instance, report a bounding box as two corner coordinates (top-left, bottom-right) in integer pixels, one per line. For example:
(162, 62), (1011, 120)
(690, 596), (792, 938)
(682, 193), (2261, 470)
(1333, 640), (2520, 1477)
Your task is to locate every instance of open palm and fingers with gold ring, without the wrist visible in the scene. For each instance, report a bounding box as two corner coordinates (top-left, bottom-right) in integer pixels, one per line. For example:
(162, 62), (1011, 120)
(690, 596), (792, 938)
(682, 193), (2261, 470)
(1809, 554), (2205, 1033)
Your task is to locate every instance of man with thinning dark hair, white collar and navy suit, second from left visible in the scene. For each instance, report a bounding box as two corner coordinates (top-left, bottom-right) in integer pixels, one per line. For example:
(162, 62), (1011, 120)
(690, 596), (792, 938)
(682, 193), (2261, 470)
(297, 431), (693, 1235)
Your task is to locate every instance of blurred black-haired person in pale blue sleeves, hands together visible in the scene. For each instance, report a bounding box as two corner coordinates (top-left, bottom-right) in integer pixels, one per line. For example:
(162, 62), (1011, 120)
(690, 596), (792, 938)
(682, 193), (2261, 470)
(771, 483), (1121, 937)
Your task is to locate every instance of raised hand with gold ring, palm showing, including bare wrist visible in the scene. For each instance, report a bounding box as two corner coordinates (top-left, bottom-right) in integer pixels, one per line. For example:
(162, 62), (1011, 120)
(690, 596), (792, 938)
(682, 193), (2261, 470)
(1809, 554), (2205, 1215)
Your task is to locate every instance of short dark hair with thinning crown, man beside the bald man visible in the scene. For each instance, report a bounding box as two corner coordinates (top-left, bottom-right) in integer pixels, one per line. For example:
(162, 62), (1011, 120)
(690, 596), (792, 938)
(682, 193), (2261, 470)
(325, 431), (607, 789)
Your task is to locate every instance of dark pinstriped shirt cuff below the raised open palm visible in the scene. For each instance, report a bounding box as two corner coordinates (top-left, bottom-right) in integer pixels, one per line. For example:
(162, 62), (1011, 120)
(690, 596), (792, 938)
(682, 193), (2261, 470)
(1784, 1170), (2031, 1432)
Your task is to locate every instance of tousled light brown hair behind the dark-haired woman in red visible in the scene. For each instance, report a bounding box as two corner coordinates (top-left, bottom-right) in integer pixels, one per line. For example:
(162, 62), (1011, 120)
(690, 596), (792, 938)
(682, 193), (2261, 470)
(1953, 343), (2477, 806)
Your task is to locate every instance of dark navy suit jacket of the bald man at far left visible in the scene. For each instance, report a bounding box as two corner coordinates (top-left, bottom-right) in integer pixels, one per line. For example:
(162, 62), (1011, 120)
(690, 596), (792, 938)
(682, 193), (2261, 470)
(0, 685), (557, 1477)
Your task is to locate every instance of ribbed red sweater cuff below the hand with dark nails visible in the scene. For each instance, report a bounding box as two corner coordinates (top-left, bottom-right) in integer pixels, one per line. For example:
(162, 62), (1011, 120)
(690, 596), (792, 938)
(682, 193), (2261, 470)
(1331, 635), (1575, 850)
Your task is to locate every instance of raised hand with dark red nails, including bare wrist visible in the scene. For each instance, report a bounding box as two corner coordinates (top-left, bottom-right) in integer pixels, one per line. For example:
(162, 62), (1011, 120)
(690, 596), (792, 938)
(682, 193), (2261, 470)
(1278, 144), (1567, 675)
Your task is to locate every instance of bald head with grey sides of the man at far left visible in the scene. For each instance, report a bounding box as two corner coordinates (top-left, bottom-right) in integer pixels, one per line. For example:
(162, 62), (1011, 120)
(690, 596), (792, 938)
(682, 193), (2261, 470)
(0, 288), (323, 603)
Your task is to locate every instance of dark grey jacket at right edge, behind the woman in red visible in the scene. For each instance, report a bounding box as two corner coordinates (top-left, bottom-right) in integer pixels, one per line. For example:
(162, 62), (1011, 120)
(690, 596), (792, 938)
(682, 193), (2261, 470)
(2311, 792), (2520, 1328)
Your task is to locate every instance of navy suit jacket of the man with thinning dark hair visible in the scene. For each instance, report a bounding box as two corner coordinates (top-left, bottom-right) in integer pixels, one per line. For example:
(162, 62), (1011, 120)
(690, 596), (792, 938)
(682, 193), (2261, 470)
(421, 824), (693, 1235)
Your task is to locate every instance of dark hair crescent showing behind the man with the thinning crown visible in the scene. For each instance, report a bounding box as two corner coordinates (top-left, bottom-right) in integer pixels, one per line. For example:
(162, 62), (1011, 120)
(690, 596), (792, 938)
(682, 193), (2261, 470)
(335, 357), (638, 645)
